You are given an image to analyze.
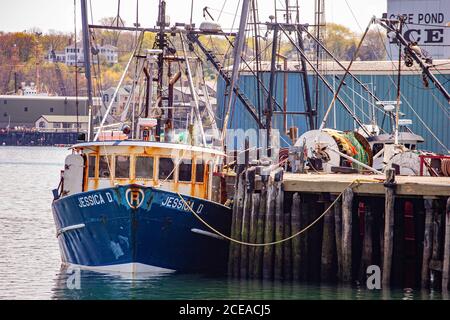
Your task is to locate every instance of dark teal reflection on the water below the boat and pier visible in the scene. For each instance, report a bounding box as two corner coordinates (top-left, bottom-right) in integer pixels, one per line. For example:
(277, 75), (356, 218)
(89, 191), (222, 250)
(52, 268), (443, 300)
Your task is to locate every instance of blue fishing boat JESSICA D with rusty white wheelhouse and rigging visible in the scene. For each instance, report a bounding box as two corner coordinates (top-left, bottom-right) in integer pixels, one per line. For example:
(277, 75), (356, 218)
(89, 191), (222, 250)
(52, 1), (231, 274)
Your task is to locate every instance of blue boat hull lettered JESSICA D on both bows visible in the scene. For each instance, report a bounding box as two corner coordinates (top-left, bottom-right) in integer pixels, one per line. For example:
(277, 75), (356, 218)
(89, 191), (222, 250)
(52, 185), (231, 274)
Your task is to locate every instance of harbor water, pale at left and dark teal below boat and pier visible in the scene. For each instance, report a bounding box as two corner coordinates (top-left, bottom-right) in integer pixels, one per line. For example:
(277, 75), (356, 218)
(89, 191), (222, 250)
(0, 146), (448, 300)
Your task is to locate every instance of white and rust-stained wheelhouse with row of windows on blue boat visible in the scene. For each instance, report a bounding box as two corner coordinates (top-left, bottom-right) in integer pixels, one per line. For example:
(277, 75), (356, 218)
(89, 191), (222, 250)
(61, 140), (224, 200)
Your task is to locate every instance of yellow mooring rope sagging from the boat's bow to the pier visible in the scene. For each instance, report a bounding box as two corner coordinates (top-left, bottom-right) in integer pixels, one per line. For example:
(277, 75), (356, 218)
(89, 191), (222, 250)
(177, 179), (382, 247)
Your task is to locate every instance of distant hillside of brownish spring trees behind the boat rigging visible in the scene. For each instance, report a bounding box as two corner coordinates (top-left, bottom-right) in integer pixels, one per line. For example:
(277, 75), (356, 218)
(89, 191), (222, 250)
(0, 18), (385, 95)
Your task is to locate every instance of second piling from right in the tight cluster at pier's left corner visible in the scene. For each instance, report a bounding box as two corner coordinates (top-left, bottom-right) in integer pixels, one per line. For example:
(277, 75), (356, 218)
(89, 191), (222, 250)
(263, 178), (277, 279)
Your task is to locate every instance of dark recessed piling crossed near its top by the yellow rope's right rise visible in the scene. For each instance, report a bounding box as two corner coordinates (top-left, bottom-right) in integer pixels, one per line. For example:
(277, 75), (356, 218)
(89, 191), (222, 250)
(320, 194), (335, 282)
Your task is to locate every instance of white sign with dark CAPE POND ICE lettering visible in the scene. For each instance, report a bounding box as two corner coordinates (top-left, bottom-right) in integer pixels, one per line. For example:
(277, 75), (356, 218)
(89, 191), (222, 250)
(387, 0), (450, 59)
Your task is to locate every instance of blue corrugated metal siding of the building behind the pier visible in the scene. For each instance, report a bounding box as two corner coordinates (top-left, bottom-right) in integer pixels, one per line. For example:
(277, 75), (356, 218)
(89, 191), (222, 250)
(217, 73), (450, 153)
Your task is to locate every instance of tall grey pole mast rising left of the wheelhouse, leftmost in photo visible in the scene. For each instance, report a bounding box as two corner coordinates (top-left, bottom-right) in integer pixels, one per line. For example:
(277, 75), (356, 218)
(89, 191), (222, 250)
(80, 0), (94, 141)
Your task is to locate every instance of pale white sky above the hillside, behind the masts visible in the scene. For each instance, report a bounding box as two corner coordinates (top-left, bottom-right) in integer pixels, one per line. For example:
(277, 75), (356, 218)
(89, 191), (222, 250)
(0, 0), (387, 32)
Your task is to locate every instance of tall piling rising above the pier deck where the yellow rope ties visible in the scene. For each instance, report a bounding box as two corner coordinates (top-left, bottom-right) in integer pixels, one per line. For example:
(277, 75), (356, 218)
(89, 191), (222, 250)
(382, 169), (395, 287)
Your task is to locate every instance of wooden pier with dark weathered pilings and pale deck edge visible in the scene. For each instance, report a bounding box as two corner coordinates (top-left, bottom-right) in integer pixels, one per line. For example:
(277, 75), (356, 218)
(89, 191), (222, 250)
(228, 165), (450, 290)
